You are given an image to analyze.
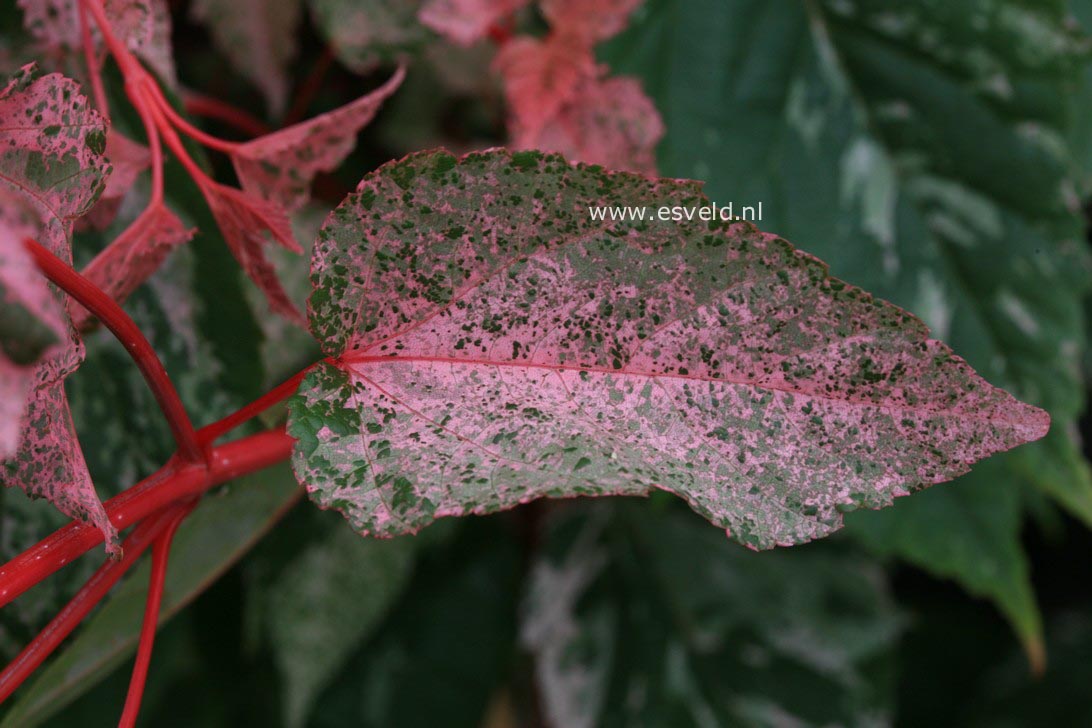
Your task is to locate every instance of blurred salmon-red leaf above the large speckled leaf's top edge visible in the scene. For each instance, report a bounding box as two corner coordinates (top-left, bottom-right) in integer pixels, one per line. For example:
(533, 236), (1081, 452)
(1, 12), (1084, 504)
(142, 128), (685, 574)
(494, 33), (597, 139)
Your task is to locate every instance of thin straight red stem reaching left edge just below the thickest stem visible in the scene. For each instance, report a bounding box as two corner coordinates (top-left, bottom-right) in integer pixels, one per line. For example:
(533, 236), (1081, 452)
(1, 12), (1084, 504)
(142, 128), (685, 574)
(0, 514), (174, 702)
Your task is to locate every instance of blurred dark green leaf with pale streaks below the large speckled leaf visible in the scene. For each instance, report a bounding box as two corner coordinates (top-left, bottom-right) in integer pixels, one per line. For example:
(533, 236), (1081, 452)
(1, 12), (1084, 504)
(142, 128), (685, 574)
(521, 504), (900, 728)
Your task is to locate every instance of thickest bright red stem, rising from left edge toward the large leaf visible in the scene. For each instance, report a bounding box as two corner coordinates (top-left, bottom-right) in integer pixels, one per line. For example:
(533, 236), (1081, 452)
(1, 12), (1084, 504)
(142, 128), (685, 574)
(0, 429), (295, 607)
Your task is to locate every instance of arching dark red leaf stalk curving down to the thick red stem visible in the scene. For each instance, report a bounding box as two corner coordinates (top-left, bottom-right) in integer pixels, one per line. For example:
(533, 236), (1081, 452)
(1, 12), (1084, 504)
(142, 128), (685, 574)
(25, 239), (204, 463)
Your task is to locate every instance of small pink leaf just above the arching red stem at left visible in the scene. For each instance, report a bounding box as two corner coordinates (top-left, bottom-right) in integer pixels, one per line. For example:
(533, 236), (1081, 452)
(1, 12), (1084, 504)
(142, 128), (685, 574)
(73, 202), (195, 329)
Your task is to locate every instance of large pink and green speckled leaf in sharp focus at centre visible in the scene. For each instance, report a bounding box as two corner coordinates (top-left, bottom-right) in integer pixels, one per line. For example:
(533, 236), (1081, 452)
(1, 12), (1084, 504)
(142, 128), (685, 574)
(289, 151), (1049, 548)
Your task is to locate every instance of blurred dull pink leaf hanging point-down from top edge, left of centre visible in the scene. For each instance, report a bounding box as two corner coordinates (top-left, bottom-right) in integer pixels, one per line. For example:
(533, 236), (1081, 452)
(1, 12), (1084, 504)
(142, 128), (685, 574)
(191, 0), (300, 115)
